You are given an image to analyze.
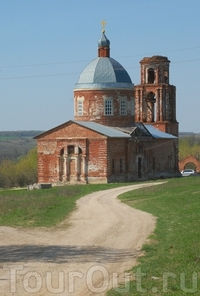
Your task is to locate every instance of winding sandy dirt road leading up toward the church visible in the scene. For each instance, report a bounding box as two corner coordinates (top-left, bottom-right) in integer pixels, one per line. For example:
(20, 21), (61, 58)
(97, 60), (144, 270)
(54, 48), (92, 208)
(0, 182), (161, 296)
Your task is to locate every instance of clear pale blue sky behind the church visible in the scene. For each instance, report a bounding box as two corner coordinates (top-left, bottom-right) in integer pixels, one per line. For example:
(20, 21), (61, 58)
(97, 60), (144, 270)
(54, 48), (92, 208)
(0, 0), (200, 133)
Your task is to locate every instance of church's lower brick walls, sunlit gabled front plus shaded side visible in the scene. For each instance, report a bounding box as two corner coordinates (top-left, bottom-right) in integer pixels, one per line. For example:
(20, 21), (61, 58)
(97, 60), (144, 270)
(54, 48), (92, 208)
(35, 122), (178, 183)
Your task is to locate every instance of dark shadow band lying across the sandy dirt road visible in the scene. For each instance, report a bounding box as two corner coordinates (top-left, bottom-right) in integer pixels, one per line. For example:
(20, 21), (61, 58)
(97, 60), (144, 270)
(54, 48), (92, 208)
(0, 245), (137, 264)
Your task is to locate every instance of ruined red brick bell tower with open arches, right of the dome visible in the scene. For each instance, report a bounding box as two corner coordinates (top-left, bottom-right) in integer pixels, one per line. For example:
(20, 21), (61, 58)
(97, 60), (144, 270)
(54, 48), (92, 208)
(135, 56), (178, 136)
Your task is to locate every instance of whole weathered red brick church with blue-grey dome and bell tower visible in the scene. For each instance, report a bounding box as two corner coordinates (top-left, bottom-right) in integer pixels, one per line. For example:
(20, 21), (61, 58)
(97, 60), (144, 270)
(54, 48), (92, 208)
(35, 30), (179, 185)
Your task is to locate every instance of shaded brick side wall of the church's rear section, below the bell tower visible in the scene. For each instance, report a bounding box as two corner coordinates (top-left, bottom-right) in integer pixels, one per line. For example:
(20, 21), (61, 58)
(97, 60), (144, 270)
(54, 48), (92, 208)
(128, 139), (178, 180)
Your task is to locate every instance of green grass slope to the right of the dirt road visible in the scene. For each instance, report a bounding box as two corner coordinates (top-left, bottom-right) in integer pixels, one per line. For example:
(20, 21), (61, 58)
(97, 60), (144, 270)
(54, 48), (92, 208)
(108, 177), (200, 296)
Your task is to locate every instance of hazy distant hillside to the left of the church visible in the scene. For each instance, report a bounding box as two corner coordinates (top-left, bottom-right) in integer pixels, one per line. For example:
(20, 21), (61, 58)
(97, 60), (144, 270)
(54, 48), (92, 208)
(0, 130), (43, 162)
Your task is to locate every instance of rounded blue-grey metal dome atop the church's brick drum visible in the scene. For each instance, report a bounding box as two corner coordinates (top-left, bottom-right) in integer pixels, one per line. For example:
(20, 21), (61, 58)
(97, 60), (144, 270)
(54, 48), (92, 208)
(76, 57), (133, 89)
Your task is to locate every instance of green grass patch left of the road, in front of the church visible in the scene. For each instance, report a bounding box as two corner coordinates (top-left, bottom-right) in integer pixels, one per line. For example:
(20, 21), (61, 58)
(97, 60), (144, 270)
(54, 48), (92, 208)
(0, 183), (134, 227)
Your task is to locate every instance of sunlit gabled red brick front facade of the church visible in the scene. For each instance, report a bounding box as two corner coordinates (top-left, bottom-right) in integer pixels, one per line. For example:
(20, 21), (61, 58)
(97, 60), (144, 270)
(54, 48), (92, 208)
(38, 123), (110, 183)
